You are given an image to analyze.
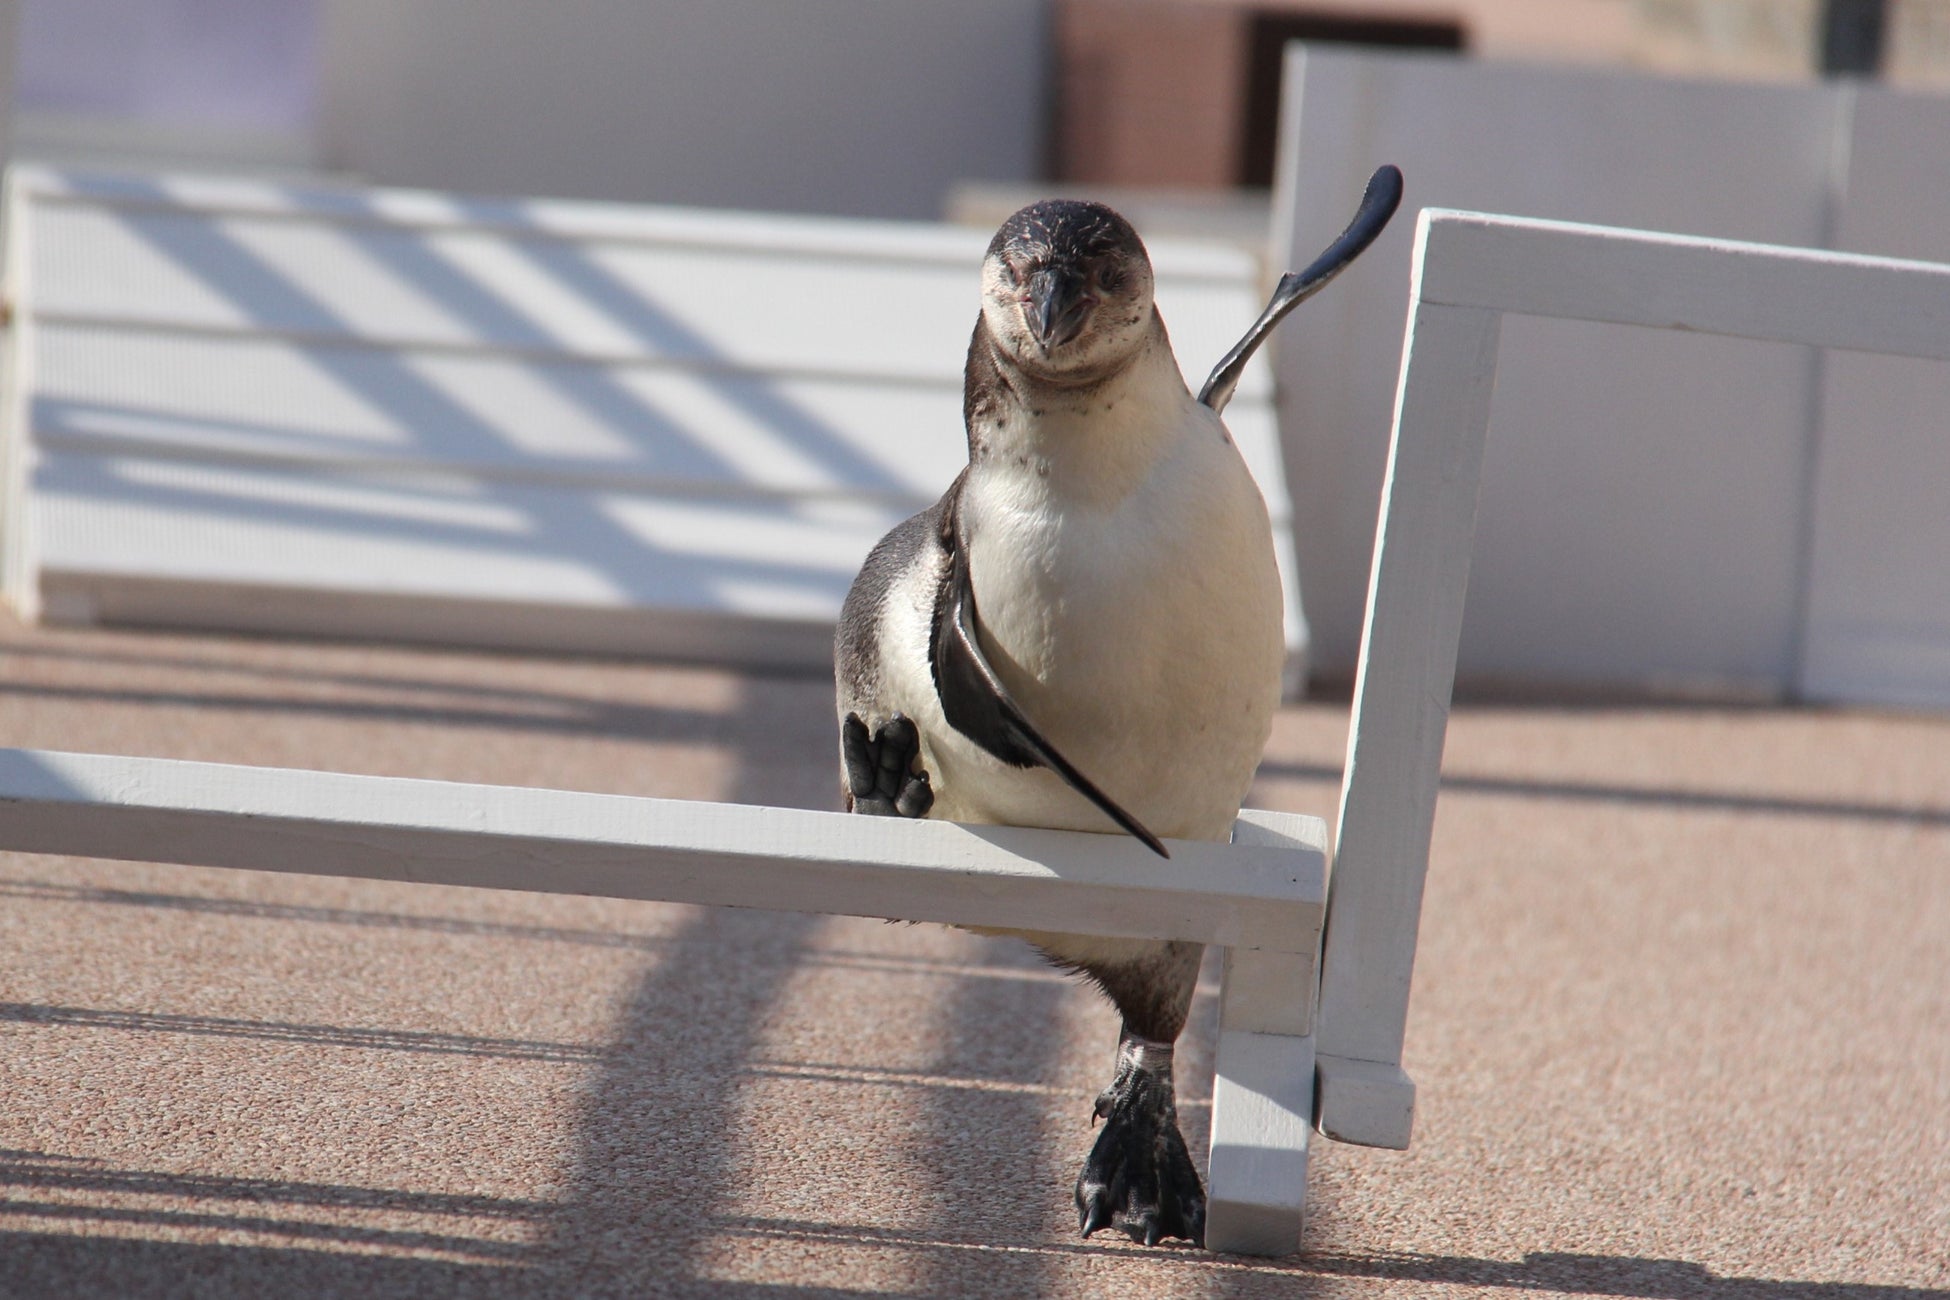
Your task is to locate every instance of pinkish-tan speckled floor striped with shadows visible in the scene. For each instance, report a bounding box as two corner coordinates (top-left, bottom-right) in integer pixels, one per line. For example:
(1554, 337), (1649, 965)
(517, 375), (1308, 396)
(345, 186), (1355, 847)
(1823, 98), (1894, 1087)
(0, 622), (1950, 1300)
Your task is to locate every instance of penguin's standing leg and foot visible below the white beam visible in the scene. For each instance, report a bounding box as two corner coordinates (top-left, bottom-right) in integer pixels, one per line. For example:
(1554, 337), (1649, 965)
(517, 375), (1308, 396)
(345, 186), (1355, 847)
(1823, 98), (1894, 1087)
(1076, 943), (1205, 1245)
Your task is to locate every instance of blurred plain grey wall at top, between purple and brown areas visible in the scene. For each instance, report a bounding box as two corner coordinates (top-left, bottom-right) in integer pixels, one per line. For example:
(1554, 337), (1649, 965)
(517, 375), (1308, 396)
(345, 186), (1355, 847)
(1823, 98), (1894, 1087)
(318, 0), (1047, 216)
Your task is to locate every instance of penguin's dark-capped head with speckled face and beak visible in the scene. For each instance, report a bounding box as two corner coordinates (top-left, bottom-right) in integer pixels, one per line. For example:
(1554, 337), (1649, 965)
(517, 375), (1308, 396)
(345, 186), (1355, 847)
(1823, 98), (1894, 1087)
(981, 199), (1152, 382)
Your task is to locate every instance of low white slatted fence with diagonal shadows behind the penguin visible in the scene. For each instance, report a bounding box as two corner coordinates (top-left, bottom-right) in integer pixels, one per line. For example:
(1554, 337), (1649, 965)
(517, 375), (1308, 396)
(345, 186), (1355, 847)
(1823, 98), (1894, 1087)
(0, 170), (1310, 697)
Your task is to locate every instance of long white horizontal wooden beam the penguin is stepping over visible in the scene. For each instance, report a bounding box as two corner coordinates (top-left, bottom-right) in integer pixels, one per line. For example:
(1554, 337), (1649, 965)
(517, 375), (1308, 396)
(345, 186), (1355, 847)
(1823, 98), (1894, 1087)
(0, 750), (1324, 951)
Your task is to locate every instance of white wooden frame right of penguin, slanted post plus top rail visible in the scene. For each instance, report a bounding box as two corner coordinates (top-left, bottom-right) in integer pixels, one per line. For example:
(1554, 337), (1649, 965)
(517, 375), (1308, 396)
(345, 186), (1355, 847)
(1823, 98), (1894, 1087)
(1316, 209), (1950, 1146)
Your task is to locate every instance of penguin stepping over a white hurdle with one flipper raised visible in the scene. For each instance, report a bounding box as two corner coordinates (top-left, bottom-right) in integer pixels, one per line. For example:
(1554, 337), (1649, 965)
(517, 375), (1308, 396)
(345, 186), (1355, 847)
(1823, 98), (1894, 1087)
(833, 168), (1400, 1245)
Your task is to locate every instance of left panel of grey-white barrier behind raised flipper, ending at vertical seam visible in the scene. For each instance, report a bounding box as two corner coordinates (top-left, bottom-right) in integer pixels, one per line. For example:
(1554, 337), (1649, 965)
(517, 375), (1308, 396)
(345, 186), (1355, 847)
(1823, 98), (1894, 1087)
(1275, 47), (1841, 694)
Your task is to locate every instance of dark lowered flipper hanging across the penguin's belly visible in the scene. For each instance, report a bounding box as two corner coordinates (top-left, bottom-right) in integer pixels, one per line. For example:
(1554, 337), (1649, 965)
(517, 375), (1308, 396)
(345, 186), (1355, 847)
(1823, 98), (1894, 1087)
(928, 493), (1170, 858)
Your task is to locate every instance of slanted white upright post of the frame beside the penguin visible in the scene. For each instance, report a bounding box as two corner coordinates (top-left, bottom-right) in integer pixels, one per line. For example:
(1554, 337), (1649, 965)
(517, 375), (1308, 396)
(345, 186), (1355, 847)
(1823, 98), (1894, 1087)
(1316, 282), (1502, 1148)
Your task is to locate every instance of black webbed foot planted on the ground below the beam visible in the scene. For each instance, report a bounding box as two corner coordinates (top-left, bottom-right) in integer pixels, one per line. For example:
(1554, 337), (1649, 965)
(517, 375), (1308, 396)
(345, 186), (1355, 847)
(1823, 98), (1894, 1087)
(1076, 1037), (1205, 1245)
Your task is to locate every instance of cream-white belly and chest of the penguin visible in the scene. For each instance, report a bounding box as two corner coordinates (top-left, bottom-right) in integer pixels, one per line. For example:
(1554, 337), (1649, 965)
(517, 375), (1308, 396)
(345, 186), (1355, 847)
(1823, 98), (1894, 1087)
(932, 419), (1285, 840)
